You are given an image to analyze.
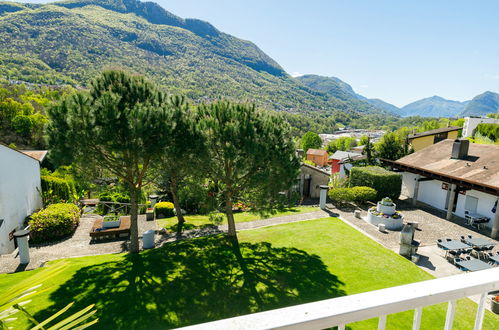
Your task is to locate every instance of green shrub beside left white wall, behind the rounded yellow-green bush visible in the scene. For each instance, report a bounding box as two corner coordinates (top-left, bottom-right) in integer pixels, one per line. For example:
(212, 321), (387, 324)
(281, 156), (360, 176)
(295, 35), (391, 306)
(41, 175), (76, 205)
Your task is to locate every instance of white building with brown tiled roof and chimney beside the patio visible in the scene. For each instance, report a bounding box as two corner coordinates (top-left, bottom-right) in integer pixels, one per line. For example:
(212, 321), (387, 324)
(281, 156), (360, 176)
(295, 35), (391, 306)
(384, 140), (499, 237)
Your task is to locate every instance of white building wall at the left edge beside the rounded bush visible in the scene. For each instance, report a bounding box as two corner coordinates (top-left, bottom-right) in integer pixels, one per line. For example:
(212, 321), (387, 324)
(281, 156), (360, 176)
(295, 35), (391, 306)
(0, 145), (42, 254)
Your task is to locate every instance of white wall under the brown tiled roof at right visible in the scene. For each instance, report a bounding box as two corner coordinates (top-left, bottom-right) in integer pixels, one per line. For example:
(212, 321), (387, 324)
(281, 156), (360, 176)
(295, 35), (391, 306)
(402, 172), (499, 228)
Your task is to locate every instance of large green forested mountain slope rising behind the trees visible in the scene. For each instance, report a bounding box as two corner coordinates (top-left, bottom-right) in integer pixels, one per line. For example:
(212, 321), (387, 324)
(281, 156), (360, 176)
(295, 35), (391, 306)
(0, 0), (387, 117)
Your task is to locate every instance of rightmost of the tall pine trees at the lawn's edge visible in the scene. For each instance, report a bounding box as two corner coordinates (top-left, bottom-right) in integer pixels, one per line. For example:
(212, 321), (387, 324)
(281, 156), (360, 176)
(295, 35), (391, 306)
(198, 102), (299, 242)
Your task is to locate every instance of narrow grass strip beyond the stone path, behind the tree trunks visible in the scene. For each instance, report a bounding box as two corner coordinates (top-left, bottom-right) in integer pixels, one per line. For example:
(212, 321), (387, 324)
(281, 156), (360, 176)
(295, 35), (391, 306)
(156, 206), (319, 231)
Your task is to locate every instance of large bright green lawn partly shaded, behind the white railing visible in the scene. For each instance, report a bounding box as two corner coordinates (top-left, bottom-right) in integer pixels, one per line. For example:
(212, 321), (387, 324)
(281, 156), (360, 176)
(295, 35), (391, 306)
(0, 218), (499, 329)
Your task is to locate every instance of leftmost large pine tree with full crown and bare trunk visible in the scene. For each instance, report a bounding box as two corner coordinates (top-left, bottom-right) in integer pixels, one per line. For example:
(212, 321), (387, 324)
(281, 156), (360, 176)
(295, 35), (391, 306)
(48, 71), (172, 252)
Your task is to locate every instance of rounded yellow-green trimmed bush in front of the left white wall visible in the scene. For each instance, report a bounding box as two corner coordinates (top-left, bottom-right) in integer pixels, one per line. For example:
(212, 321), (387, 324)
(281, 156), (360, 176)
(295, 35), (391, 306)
(29, 203), (80, 243)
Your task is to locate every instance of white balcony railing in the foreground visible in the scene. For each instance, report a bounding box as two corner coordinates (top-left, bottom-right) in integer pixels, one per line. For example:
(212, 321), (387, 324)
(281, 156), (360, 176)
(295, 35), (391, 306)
(178, 267), (499, 330)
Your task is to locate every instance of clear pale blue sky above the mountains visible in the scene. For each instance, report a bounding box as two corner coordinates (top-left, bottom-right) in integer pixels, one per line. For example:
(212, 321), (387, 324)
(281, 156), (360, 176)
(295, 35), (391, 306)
(17, 0), (499, 106)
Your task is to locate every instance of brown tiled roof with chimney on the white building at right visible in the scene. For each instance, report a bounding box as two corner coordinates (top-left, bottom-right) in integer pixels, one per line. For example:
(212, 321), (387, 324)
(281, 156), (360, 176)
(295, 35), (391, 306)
(393, 139), (499, 193)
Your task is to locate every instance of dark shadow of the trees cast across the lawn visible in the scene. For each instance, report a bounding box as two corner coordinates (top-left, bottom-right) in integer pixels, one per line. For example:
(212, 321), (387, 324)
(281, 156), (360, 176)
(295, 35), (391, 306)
(36, 235), (345, 329)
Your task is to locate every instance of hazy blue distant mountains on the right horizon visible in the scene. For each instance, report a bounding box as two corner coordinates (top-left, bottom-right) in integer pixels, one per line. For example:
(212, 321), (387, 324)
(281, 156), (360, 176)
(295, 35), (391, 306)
(296, 75), (499, 117)
